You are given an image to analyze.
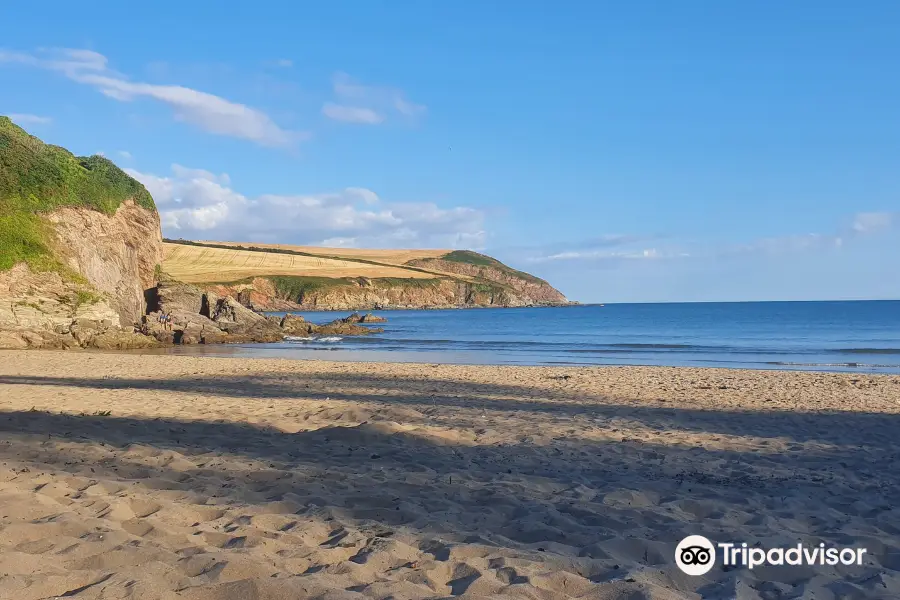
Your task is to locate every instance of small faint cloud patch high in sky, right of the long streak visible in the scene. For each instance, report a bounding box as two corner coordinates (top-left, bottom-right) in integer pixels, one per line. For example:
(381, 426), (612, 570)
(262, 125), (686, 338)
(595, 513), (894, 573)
(322, 73), (427, 125)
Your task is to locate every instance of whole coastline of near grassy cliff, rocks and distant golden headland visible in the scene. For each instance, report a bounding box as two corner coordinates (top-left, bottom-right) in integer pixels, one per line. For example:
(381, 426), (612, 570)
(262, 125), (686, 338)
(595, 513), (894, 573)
(0, 117), (566, 348)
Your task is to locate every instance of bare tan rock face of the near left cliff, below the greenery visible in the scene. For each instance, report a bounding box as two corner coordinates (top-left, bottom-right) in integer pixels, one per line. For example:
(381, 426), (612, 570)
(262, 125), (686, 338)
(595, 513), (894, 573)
(0, 201), (162, 349)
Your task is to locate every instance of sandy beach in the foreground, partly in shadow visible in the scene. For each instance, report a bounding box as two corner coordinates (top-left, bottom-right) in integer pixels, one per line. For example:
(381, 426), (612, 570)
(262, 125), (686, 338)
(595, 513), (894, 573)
(0, 351), (900, 600)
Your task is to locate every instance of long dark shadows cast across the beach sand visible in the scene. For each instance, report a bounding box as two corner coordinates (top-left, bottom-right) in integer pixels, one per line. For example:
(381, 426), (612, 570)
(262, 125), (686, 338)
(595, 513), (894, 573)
(0, 374), (900, 595)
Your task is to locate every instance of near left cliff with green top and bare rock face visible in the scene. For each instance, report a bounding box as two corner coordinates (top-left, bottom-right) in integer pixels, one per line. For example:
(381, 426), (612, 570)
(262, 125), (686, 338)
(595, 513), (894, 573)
(0, 117), (162, 348)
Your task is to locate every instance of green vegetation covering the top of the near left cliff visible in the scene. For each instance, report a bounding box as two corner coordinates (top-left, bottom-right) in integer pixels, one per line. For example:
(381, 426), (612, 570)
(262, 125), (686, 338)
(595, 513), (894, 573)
(0, 116), (156, 271)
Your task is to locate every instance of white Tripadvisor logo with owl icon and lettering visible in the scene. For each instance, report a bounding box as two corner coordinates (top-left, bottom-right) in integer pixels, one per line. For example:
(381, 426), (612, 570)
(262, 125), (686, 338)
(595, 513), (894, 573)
(675, 535), (866, 576)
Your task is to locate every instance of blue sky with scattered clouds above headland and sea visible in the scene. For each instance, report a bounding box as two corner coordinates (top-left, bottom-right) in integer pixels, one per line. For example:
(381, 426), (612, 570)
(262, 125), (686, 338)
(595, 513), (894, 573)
(0, 0), (900, 302)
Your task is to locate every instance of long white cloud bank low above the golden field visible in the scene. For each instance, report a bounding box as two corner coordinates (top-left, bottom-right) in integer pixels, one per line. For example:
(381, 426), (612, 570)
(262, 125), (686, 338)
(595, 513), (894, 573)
(126, 165), (486, 249)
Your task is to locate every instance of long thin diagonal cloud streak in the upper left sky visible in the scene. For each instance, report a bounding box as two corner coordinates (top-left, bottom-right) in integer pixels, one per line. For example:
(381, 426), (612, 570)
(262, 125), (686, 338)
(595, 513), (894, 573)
(0, 49), (306, 147)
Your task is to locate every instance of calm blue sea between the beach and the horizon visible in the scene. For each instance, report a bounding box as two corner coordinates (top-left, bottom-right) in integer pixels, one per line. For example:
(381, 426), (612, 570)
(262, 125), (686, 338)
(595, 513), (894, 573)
(151, 300), (900, 374)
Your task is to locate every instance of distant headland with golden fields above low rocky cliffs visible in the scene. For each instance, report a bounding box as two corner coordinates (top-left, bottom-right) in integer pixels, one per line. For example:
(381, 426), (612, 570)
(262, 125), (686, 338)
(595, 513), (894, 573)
(163, 240), (569, 310)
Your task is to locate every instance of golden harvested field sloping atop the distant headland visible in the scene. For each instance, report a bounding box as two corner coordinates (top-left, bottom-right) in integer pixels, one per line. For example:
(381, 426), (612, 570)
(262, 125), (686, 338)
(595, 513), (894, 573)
(162, 242), (440, 283)
